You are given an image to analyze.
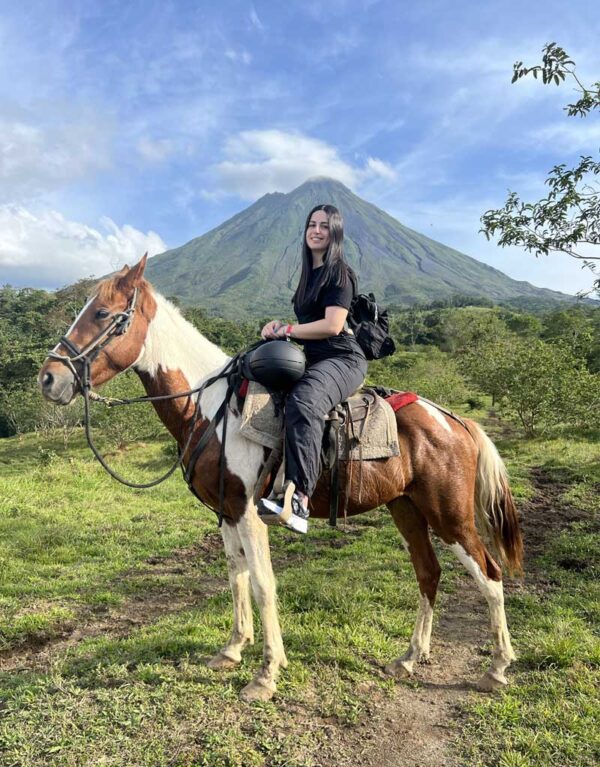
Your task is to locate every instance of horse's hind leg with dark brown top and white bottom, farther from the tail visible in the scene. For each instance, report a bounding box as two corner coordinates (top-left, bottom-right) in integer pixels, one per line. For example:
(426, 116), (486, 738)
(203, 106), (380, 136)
(385, 497), (441, 677)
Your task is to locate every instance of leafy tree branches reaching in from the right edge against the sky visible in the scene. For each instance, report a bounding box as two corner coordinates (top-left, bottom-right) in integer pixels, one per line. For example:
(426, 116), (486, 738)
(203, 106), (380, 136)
(481, 43), (600, 294)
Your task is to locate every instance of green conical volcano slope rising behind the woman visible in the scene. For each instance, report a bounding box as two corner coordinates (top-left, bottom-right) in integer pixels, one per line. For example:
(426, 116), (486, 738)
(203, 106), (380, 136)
(147, 178), (572, 318)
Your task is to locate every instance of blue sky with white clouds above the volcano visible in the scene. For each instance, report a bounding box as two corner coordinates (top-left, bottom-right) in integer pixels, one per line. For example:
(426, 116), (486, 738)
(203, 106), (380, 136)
(0, 0), (600, 293)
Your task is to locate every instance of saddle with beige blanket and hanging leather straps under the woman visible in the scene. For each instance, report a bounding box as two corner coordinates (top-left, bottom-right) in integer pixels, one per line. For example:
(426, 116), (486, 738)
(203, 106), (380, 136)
(240, 381), (400, 526)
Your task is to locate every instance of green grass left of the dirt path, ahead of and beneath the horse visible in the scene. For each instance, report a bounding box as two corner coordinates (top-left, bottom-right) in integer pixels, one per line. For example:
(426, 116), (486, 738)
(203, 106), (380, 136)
(0, 428), (426, 767)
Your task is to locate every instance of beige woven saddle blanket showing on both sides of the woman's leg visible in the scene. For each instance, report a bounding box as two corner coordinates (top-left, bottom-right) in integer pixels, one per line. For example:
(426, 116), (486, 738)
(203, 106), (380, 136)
(240, 381), (400, 461)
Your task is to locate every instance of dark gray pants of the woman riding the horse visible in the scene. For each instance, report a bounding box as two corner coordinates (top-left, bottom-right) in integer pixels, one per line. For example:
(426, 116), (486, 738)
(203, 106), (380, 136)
(285, 354), (367, 496)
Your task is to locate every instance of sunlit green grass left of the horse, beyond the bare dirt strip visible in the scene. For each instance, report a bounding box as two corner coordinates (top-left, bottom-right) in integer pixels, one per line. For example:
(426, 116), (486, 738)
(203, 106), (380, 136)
(0, 435), (214, 649)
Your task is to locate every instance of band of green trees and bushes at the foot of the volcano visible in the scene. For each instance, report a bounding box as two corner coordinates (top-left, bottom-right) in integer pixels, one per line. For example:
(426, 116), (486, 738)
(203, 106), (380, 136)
(0, 280), (600, 447)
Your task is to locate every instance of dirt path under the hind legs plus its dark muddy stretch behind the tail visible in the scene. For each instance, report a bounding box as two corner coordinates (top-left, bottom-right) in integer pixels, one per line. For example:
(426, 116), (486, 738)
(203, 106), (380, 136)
(318, 469), (587, 767)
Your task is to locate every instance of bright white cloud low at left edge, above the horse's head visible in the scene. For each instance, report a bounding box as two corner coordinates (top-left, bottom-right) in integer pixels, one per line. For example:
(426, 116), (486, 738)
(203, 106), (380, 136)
(0, 205), (167, 288)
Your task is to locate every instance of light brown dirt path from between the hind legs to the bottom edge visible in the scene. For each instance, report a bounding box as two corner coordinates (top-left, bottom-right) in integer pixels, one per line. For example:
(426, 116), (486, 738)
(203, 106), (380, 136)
(318, 568), (488, 767)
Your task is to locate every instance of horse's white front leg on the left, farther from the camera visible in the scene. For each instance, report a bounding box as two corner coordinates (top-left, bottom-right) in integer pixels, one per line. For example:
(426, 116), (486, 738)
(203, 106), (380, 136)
(208, 522), (254, 669)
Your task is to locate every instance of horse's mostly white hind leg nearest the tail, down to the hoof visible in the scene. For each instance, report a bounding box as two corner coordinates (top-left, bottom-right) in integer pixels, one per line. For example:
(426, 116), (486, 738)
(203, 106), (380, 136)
(450, 526), (516, 691)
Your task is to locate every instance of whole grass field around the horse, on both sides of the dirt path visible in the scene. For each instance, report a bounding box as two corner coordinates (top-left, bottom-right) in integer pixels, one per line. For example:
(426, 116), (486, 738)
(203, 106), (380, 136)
(0, 426), (600, 767)
